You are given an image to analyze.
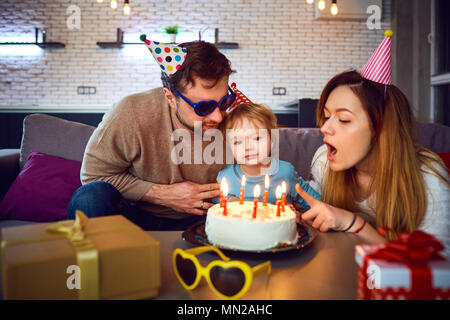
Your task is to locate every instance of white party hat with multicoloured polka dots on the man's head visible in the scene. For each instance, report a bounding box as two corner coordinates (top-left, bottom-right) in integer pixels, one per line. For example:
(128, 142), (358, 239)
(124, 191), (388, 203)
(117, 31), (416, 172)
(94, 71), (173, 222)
(140, 34), (187, 77)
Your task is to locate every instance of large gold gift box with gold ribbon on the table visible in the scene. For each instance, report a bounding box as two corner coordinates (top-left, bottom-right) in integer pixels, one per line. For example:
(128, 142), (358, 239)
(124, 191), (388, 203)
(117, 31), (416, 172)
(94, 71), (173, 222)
(1, 211), (161, 299)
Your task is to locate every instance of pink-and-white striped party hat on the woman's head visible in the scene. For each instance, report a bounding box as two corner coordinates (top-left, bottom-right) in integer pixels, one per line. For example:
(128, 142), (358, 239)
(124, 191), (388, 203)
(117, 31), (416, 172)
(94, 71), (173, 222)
(360, 30), (393, 85)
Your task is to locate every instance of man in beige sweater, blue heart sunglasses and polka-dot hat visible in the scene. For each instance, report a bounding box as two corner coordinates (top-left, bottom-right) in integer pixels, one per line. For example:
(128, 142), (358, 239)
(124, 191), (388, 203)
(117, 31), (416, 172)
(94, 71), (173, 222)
(69, 40), (236, 230)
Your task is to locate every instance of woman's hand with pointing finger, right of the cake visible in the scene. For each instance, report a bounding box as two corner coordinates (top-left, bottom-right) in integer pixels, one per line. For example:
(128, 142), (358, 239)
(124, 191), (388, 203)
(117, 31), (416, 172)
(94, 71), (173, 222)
(295, 184), (353, 232)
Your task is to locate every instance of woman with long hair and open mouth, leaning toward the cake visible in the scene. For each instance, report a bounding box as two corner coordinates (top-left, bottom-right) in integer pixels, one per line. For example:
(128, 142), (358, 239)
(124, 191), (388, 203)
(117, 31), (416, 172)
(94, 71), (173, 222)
(297, 71), (450, 255)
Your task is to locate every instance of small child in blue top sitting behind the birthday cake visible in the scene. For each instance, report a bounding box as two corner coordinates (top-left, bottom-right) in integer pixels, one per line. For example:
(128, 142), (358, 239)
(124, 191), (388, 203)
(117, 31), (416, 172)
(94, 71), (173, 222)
(217, 103), (320, 209)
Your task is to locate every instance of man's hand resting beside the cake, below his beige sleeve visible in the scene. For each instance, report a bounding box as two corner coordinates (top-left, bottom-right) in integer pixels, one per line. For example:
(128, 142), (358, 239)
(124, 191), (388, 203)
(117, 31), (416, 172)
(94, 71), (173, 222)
(141, 181), (220, 215)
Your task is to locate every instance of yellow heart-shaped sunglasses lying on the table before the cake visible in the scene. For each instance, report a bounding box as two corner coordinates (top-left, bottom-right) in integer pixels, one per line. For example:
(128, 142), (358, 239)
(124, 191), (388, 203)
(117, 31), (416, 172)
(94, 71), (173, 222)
(173, 247), (271, 299)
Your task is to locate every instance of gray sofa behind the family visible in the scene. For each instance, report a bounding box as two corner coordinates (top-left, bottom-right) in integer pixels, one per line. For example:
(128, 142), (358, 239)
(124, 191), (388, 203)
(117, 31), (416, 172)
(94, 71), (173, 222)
(0, 114), (450, 228)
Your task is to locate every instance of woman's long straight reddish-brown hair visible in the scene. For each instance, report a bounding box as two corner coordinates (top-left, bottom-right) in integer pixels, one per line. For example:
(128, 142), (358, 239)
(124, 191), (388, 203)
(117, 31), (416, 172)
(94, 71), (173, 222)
(317, 71), (450, 239)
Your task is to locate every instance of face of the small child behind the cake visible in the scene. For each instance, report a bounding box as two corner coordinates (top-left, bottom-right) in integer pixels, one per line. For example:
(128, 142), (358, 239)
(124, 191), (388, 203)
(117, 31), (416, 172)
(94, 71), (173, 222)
(227, 118), (271, 166)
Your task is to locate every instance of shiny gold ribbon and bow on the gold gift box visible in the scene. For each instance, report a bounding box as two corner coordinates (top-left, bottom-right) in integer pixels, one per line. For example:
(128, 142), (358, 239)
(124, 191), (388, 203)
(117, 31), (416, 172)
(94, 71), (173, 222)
(47, 210), (100, 300)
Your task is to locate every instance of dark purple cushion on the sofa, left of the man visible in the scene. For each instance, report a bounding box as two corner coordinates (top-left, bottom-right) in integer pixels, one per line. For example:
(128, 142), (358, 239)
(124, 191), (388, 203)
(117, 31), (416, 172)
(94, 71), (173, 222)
(0, 151), (81, 222)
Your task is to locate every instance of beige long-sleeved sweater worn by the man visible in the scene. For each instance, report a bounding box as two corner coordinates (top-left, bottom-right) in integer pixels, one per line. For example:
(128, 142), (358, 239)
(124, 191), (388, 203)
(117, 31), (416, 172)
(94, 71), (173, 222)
(81, 88), (226, 218)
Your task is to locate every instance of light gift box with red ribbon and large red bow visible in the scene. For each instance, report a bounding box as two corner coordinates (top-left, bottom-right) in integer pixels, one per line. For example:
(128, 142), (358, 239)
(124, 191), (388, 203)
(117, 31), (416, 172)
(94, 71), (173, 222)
(356, 231), (450, 300)
